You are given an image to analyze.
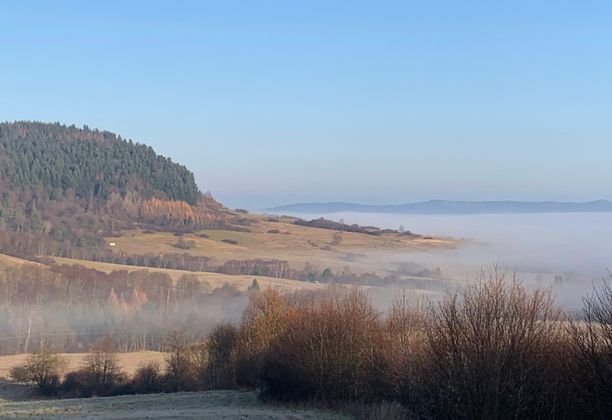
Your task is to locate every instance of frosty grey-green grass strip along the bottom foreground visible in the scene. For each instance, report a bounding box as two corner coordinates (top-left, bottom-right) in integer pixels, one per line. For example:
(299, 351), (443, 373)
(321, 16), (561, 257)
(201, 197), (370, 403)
(0, 391), (347, 420)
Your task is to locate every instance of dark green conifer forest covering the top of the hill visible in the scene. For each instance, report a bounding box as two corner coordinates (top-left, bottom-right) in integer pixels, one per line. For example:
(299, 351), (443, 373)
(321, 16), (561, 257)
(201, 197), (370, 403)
(0, 122), (200, 205)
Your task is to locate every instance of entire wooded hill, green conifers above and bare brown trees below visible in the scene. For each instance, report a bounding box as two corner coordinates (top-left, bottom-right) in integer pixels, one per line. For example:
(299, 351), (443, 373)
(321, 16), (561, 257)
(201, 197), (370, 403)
(0, 121), (229, 257)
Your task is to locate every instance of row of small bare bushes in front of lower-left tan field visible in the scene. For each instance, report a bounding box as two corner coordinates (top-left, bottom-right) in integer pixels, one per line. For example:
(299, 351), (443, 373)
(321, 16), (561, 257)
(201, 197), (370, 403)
(10, 324), (238, 397)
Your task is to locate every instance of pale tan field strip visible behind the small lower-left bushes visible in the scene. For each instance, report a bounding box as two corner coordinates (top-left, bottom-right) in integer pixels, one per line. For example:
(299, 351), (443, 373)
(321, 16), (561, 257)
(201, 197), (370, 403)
(0, 351), (165, 378)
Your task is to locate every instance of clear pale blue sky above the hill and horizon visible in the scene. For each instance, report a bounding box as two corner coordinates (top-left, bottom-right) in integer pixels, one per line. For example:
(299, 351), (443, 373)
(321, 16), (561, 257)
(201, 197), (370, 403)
(0, 0), (612, 208)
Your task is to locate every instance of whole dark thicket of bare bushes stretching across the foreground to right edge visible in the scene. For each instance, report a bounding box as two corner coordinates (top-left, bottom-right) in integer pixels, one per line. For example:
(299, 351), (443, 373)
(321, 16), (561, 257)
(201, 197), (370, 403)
(10, 271), (612, 419)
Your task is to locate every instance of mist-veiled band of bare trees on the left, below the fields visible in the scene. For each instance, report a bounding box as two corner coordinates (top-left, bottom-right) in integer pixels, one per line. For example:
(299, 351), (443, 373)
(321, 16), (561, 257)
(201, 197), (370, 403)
(0, 266), (246, 354)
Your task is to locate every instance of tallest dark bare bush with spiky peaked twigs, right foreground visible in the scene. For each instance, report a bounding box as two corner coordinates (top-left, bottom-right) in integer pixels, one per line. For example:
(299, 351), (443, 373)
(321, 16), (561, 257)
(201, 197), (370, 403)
(422, 268), (559, 419)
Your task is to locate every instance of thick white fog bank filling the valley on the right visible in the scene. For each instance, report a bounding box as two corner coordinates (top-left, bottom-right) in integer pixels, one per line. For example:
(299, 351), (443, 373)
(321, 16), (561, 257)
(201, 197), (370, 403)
(284, 213), (612, 306)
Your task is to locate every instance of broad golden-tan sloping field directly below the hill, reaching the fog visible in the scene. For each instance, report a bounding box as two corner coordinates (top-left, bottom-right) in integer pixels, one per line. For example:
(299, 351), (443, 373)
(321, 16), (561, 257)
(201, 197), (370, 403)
(101, 215), (457, 275)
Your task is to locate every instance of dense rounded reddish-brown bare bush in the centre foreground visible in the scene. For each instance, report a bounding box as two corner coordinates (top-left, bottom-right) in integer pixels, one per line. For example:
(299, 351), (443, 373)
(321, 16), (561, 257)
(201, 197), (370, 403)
(262, 289), (382, 401)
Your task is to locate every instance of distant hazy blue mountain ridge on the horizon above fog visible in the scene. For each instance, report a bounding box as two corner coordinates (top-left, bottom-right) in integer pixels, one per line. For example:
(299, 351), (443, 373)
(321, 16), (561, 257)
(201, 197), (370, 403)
(266, 200), (612, 214)
